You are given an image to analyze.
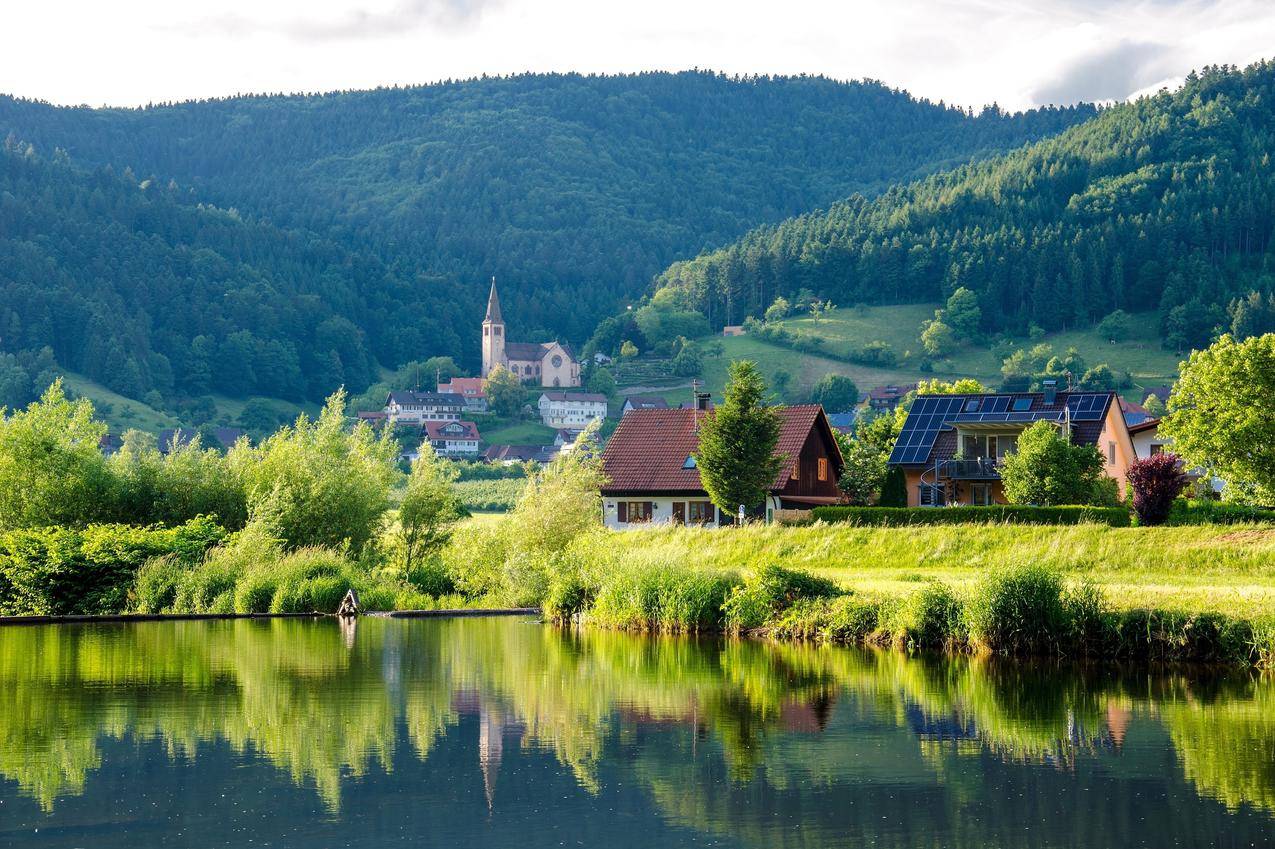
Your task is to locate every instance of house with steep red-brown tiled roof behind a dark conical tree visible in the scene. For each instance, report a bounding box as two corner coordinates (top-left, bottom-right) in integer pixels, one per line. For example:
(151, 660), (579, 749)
(602, 404), (843, 529)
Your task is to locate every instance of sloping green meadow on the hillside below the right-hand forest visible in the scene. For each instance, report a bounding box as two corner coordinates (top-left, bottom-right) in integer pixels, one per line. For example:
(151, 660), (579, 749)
(704, 303), (1179, 400)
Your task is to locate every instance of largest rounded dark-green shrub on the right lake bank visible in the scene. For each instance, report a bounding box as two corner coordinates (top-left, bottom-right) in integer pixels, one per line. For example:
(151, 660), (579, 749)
(966, 566), (1068, 654)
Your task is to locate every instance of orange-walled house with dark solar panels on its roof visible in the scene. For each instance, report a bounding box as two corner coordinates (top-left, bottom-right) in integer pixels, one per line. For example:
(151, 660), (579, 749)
(890, 381), (1137, 507)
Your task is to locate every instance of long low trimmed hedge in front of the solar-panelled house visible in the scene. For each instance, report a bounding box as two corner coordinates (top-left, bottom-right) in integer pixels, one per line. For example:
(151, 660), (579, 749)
(813, 505), (1130, 528)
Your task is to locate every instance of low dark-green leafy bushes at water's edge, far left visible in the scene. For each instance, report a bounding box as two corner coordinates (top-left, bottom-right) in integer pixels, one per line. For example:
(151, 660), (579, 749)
(0, 519), (226, 616)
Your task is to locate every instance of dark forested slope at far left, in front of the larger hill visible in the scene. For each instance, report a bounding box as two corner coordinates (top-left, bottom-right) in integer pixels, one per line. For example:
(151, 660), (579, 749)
(0, 142), (392, 407)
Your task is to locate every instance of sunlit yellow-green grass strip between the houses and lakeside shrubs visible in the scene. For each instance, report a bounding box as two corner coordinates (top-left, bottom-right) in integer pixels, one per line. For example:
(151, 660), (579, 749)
(573, 525), (1275, 617)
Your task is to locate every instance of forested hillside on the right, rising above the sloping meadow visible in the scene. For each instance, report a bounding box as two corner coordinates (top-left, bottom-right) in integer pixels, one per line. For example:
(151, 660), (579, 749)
(659, 64), (1275, 347)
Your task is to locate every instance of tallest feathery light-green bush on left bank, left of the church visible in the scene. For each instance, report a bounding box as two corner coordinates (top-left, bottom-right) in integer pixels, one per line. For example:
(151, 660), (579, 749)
(228, 391), (400, 556)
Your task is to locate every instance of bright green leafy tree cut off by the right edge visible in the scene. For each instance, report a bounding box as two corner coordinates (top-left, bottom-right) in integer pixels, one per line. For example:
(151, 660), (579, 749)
(1159, 333), (1275, 506)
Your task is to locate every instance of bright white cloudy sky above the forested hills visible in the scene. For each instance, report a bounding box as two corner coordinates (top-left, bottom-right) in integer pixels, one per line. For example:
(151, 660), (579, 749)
(7, 0), (1275, 108)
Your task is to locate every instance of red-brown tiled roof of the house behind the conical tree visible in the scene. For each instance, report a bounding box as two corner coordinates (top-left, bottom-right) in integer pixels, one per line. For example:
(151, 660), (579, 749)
(602, 404), (824, 492)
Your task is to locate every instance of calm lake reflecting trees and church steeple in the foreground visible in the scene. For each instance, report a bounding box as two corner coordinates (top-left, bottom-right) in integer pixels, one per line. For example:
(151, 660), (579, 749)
(0, 617), (1275, 849)
